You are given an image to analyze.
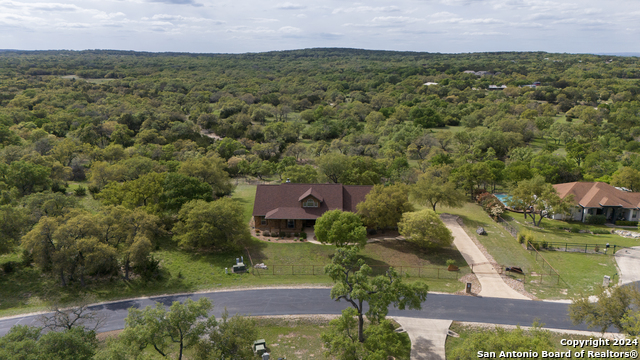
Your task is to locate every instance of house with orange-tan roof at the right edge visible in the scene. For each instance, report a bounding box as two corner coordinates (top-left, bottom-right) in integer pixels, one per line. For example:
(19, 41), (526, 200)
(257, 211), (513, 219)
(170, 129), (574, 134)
(553, 182), (640, 223)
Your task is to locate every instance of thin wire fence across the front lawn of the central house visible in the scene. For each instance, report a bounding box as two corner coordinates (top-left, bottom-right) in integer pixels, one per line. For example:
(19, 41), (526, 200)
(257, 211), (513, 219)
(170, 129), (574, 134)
(252, 264), (472, 280)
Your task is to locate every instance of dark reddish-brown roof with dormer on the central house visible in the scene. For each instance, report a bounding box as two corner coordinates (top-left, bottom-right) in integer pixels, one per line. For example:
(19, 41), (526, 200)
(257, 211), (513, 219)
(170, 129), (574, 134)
(253, 183), (373, 219)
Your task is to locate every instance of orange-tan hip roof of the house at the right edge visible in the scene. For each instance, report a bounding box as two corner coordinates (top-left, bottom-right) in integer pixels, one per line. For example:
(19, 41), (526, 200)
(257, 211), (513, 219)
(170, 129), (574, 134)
(553, 182), (640, 209)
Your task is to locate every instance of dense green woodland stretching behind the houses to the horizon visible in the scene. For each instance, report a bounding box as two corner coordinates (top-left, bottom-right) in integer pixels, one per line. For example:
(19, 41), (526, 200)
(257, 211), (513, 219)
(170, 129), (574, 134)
(0, 49), (640, 358)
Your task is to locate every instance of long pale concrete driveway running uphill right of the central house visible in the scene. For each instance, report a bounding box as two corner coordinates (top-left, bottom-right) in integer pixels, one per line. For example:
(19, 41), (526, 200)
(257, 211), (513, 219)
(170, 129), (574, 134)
(440, 214), (530, 300)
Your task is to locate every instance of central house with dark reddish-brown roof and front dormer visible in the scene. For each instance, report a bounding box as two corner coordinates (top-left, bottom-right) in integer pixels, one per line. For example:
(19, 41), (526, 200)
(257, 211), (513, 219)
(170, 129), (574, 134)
(253, 182), (373, 232)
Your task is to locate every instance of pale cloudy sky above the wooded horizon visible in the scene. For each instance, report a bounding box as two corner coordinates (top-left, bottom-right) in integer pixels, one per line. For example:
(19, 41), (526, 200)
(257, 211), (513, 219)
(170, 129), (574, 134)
(0, 0), (640, 53)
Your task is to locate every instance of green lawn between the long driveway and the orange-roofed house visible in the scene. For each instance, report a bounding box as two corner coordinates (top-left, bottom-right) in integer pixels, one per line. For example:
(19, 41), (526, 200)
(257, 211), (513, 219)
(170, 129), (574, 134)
(440, 203), (638, 299)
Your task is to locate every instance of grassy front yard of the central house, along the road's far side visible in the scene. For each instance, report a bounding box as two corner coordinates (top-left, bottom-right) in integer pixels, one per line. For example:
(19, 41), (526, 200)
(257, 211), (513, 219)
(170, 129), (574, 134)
(0, 185), (468, 316)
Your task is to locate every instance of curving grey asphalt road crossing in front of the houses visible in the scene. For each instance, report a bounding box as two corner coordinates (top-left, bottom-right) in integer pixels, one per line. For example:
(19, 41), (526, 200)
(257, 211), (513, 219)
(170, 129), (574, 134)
(0, 289), (600, 336)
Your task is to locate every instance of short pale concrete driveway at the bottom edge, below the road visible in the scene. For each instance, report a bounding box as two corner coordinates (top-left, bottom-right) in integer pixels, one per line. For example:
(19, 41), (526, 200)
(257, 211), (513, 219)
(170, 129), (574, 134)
(392, 316), (452, 360)
